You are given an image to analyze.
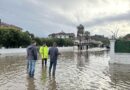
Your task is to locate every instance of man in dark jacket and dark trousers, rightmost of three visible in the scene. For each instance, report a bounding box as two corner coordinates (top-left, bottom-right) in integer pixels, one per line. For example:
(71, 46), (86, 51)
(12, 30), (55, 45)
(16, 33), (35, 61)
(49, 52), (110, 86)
(49, 42), (59, 76)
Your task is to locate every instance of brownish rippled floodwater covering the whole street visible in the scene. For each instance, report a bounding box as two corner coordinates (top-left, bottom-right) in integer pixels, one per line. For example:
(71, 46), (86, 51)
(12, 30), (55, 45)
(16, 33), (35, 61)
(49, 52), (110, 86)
(0, 51), (130, 90)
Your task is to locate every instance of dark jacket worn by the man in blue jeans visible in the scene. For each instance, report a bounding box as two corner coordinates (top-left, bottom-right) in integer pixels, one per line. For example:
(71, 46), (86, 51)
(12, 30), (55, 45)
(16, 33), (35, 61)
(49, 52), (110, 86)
(27, 45), (37, 60)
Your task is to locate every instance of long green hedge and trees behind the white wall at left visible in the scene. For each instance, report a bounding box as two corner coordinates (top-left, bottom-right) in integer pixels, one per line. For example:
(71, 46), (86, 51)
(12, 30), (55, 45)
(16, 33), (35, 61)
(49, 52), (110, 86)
(0, 27), (73, 48)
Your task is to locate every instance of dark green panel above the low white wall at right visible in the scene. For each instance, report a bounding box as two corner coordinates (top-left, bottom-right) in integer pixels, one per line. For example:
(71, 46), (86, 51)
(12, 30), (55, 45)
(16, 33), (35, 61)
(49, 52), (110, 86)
(115, 40), (130, 53)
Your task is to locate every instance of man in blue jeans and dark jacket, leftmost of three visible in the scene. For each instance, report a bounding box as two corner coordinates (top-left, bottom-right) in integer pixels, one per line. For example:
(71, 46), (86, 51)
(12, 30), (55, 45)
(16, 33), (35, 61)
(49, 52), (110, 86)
(27, 41), (37, 77)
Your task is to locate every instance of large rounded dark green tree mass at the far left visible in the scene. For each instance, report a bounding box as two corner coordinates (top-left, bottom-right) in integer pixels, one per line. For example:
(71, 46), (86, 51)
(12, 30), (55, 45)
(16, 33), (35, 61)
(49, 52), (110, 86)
(0, 27), (31, 48)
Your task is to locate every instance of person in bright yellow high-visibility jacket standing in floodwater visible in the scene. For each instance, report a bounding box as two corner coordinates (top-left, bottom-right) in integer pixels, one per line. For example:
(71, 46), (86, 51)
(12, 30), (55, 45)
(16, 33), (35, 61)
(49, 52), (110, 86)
(39, 43), (48, 67)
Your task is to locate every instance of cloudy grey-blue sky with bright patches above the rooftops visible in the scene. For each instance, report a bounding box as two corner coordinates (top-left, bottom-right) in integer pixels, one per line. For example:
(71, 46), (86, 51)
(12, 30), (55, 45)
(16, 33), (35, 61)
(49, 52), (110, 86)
(0, 0), (130, 37)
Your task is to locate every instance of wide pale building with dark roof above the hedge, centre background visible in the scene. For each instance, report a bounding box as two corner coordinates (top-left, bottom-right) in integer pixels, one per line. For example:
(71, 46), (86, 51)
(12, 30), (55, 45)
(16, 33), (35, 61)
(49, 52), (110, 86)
(48, 31), (75, 39)
